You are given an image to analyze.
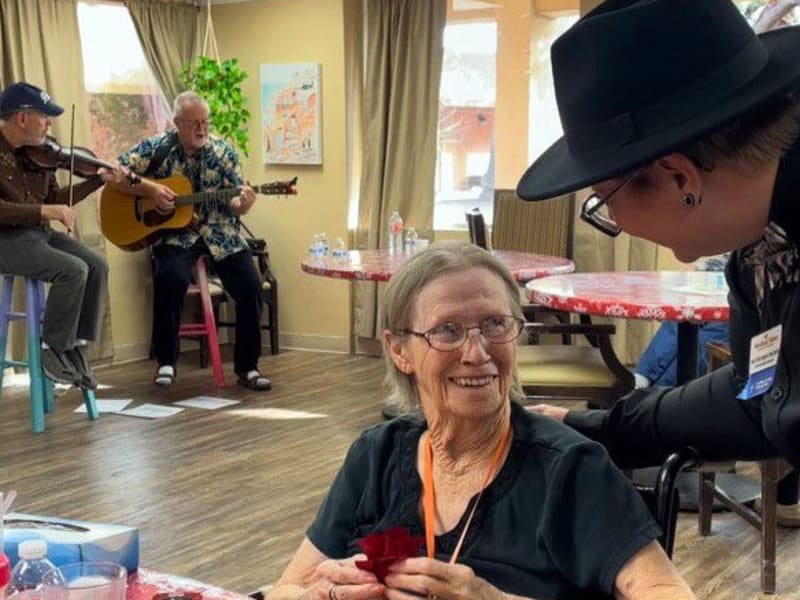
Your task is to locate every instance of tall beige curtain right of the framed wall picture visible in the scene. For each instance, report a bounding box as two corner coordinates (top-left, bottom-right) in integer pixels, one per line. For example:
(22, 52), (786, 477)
(345, 0), (447, 352)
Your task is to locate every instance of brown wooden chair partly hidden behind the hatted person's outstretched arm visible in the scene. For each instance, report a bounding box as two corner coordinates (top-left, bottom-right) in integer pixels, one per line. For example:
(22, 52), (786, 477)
(697, 342), (791, 594)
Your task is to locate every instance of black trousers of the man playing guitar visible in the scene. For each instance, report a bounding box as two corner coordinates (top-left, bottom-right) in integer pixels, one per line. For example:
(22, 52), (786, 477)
(153, 241), (262, 374)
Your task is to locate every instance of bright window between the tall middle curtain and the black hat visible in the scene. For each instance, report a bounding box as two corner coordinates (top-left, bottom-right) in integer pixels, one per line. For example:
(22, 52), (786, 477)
(434, 7), (578, 230)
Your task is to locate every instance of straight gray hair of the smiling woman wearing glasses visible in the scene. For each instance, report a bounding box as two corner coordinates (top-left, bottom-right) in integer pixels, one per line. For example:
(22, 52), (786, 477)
(381, 241), (524, 412)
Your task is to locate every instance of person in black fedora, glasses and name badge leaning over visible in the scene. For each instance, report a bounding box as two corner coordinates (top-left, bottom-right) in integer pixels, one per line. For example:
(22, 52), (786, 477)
(517, 0), (800, 524)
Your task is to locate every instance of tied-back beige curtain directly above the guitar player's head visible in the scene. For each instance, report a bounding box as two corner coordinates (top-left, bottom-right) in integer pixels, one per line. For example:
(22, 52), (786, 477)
(125, 1), (200, 106)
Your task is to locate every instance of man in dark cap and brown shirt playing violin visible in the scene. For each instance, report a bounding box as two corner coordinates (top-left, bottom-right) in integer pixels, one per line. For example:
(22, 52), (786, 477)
(0, 82), (124, 389)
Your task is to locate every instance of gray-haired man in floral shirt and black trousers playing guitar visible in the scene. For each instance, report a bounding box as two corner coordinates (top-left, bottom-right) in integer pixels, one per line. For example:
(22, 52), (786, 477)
(106, 92), (271, 390)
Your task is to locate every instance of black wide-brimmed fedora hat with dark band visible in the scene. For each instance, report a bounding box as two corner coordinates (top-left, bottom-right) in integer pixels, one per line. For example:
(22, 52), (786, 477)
(517, 0), (800, 200)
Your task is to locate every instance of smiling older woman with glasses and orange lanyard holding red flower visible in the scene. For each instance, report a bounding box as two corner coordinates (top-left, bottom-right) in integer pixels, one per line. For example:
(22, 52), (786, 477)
(269, 242), (695, 600)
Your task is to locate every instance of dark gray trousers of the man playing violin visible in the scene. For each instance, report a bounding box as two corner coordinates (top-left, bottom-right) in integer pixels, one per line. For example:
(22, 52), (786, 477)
(0, 227), (108, 352)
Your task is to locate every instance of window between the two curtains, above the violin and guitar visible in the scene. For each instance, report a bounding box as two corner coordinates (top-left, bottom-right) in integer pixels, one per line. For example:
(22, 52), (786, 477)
(78, 2), (170, 160)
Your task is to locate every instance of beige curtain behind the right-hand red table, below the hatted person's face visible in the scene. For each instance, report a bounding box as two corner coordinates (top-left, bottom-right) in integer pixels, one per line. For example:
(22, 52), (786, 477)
(572, 0), (658, 364)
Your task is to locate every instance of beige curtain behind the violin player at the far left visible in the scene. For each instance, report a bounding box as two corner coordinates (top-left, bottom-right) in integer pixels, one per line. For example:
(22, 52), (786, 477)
(0, 0), (114, 359)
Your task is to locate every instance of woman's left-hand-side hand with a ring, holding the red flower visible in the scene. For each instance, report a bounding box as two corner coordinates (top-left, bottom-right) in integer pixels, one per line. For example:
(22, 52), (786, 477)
(304, 554), (385, 600)
